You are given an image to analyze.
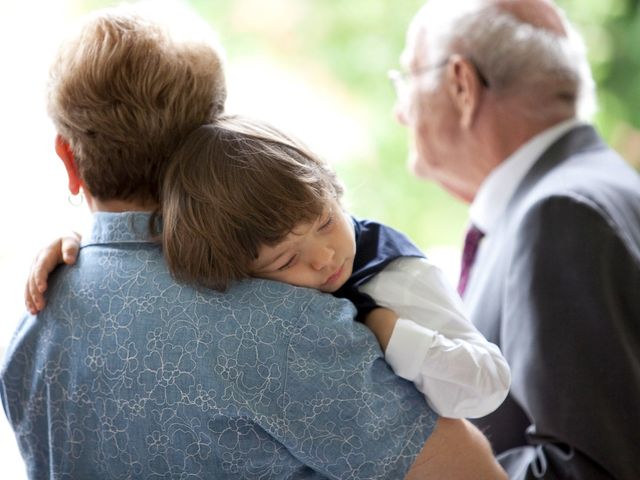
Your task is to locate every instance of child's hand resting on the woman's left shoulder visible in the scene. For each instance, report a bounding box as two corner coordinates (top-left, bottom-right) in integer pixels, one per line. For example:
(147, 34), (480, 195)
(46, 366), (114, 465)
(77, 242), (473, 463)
(24, 232), (82, 315)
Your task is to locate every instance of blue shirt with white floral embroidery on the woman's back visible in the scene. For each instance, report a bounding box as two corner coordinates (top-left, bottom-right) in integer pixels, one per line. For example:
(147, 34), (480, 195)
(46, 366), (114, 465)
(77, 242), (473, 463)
(1, 214), (436, 479)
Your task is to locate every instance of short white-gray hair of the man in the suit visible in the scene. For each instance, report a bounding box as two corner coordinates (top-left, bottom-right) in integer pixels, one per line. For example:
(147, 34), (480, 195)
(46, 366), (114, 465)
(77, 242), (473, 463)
(418, 0), (596, 119)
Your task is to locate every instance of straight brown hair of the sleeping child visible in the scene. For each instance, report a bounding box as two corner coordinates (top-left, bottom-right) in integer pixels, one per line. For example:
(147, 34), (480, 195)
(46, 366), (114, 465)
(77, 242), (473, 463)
(162, 116), (343, 291)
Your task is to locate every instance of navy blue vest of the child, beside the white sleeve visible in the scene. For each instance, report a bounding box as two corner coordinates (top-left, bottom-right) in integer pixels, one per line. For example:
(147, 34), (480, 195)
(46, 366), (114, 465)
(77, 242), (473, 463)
(333, 218), (425, 321)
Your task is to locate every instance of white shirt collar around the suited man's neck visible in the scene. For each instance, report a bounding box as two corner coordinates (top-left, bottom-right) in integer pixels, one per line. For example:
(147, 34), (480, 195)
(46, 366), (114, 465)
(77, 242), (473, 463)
(469, 118), (582, 234)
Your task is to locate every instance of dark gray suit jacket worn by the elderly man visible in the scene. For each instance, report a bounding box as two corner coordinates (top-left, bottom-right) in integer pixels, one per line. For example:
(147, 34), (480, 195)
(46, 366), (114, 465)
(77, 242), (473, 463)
(464, 126), (640, 480)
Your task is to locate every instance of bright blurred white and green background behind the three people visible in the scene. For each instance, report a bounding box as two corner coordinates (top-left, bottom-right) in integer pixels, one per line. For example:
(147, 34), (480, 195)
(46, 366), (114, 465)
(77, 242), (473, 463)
(0, 0), (640, 479)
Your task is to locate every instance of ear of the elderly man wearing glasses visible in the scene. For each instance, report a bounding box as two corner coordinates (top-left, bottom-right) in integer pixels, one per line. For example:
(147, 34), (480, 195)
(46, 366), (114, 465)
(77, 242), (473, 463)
(447, 54), (483, 128)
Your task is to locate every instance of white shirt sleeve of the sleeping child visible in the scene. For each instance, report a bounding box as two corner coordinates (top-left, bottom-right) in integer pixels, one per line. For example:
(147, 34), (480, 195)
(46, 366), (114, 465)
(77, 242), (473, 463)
(361, 257), (511, 418)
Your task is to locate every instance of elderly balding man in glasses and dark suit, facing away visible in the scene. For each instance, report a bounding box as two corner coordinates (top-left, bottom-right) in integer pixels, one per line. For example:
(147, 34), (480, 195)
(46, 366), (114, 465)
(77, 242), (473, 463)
(395, 0), (640, 479)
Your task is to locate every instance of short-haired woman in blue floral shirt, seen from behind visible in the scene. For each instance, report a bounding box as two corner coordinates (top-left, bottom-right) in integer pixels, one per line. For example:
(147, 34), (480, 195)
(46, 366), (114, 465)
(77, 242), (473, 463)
(0, 1), (504, 479)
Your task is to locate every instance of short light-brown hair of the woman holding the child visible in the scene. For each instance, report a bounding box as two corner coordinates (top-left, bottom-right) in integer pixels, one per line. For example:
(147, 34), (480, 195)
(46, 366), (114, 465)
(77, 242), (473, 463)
(48, 5), (226, 202)
